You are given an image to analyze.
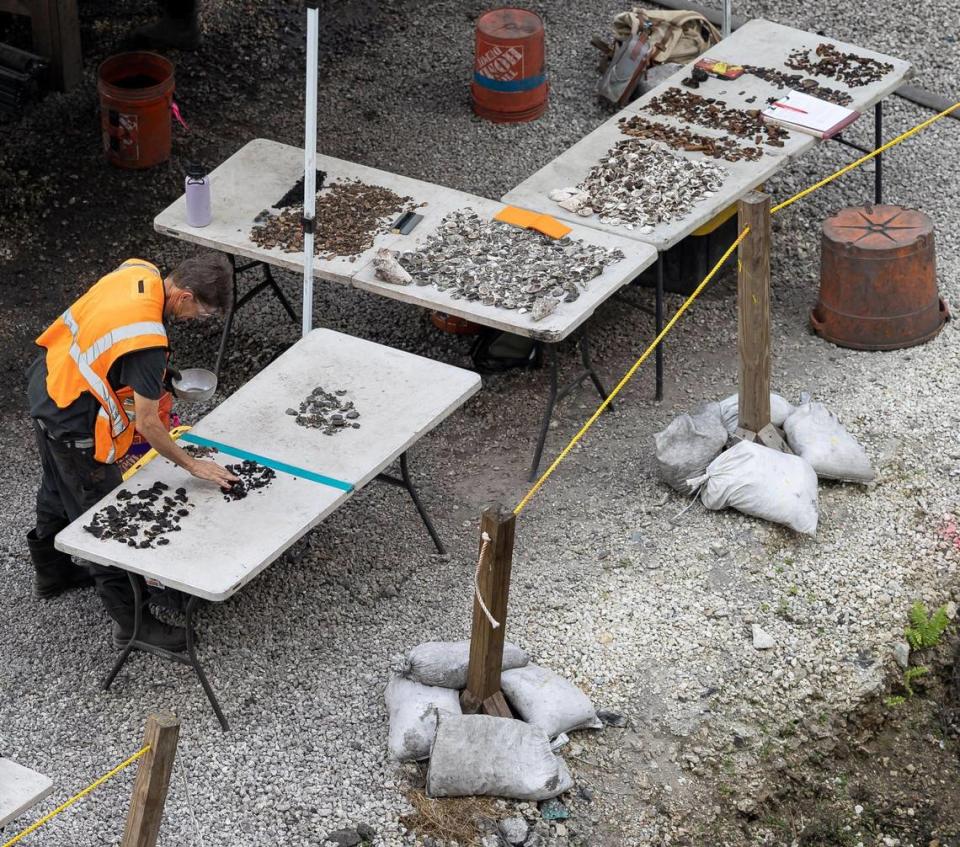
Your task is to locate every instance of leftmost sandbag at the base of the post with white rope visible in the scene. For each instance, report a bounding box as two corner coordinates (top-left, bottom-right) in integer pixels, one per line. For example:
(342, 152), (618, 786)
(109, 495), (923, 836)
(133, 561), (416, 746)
(384, 676), (461, 762)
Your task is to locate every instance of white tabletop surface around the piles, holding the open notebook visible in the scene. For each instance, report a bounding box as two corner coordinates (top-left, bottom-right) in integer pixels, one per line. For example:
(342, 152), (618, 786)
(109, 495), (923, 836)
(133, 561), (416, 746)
(502, 19), (911, 250)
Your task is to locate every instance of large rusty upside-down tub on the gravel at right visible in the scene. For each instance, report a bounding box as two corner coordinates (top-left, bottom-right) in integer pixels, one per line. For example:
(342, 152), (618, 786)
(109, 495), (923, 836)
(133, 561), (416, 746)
(810, 206), (949, 350)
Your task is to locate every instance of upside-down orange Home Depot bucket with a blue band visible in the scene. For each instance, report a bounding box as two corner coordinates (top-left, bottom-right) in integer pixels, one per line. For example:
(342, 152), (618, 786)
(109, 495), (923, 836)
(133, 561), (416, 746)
(470, 7), (549, 123)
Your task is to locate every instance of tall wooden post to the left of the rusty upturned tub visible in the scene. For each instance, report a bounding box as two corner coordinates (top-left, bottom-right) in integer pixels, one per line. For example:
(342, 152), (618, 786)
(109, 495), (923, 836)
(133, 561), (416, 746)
(737, 191), (770, 433)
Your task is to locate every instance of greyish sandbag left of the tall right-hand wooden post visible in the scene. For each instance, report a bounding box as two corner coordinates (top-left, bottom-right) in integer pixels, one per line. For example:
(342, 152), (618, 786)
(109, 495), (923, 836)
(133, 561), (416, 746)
(653, 403), (729, 492)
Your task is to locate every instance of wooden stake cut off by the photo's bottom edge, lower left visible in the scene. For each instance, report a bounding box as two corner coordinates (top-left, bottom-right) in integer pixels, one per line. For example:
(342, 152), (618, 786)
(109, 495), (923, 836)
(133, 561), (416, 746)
(120, 712), (180, 847)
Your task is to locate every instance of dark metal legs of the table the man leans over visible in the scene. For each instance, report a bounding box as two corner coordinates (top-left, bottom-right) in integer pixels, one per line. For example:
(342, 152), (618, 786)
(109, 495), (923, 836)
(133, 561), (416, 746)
(101, 450), (447, 732)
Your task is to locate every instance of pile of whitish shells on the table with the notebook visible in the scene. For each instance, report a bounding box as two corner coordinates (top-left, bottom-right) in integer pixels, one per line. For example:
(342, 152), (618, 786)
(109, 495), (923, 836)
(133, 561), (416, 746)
(549, 138), (727, 234)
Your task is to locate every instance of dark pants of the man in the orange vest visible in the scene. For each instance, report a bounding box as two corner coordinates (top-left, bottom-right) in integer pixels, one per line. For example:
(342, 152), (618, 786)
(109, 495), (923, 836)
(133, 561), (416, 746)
(33, 421), (139, 628)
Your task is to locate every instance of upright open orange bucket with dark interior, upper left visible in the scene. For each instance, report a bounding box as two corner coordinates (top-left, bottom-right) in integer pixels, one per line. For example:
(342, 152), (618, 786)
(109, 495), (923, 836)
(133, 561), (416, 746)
(97, 52), (174, 170)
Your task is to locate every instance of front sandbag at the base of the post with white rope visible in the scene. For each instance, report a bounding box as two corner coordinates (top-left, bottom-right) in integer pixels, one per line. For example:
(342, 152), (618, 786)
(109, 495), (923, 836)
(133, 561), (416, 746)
(427, 715), (573, 800)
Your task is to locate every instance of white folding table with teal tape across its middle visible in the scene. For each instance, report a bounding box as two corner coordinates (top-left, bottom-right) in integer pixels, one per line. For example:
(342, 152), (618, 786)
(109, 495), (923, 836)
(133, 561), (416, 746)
(56, 329), (480, 729)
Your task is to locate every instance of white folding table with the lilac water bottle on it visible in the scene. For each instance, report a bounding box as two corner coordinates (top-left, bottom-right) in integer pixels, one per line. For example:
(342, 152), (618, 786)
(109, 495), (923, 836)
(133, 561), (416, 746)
(154, 138), (657, 477)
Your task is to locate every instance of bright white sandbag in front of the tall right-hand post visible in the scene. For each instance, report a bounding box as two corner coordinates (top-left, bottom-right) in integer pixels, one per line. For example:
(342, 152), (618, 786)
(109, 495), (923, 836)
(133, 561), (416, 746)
(687, 441), (818, 535)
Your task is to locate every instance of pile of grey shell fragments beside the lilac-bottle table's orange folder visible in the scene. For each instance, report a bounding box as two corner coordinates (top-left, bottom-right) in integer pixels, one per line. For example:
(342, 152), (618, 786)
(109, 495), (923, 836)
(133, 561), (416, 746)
(399, 209), (624, 321)
